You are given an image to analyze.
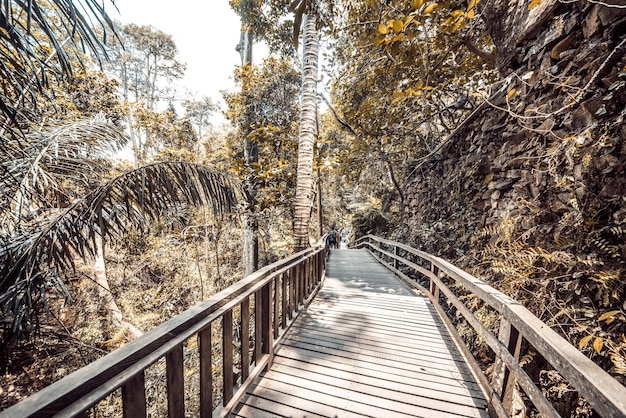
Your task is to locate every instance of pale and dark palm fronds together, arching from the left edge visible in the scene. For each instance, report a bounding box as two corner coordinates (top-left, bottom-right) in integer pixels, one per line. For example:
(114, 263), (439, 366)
(0, 119), (238, 342)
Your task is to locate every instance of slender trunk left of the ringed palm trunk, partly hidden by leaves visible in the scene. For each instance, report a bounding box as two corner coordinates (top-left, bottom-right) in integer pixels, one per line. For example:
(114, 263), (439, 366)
(237, 1), (259, 277)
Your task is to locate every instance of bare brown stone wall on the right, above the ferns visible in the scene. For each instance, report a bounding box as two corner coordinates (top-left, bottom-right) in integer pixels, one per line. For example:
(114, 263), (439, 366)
(403, 0), (626, 258)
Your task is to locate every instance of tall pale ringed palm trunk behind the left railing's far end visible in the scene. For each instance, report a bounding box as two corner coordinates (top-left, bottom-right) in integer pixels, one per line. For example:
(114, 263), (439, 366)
(293, 14), (319, 252)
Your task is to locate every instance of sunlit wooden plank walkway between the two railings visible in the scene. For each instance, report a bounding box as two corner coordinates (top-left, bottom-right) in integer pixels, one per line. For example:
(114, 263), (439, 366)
(233, 250), (488, 417)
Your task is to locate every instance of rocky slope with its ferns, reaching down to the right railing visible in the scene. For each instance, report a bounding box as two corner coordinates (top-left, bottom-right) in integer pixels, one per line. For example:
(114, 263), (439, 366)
(395, 0), (626, 398)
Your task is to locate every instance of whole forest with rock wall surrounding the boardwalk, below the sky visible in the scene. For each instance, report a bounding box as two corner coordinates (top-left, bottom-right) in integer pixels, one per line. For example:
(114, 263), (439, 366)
(0, 0), (626, 417)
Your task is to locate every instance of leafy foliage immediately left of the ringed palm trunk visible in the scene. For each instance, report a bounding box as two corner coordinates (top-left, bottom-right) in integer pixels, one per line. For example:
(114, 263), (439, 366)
(224, 58), (300, 211)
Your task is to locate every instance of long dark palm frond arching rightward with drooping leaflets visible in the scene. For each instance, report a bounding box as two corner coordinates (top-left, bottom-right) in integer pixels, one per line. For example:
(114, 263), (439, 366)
(0, 162), (240, 334)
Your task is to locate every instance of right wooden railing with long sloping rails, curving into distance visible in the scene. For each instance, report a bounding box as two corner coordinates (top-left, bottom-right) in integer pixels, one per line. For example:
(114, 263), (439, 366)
(355, 235), (626, 417)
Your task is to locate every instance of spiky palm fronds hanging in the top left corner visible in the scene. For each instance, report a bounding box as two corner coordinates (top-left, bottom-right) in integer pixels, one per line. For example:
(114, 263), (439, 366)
(0, 0), (115, 139)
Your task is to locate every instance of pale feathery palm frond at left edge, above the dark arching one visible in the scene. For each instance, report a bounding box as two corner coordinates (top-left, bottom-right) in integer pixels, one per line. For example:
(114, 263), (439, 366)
(0, 117), (129, 233)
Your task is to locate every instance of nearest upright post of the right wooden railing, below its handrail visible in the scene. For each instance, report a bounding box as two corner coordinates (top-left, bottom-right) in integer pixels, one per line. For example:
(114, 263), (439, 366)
(492, 318), (522, 410)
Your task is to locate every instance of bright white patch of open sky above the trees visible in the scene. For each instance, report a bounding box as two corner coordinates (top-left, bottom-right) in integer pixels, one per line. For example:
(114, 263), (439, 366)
(107, 0), (244, 110)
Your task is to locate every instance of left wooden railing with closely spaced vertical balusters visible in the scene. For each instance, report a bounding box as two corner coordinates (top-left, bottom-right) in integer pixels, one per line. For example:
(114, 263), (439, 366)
(0, 241), (326, 418)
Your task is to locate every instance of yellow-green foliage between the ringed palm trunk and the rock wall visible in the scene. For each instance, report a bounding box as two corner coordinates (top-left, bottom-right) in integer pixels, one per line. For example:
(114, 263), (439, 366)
(327, 1), (496, 227)
